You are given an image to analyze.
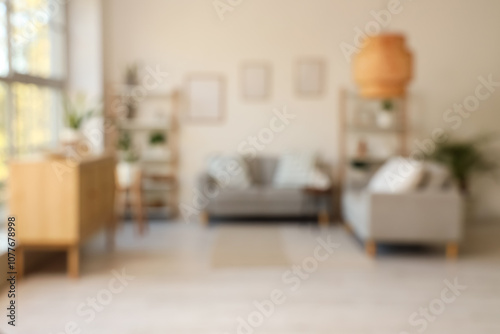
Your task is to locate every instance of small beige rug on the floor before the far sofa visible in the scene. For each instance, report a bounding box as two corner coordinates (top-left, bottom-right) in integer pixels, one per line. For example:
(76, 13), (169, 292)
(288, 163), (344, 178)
(212, 225), (290, 268)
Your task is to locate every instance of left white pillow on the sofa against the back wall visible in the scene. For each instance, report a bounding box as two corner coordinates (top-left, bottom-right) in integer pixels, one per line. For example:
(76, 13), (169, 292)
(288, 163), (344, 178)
(207, 155), (252, 189)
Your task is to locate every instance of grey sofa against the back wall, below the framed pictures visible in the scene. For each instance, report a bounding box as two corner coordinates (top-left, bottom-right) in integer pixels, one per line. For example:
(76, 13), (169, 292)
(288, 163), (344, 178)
(199, 157), (331, 223)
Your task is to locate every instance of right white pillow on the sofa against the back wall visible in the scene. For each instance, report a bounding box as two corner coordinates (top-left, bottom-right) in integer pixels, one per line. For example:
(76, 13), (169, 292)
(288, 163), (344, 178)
(273, 153), (315, 188)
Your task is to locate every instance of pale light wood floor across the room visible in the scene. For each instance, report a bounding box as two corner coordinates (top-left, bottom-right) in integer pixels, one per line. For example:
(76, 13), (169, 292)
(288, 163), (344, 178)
(0, 223), (500, 334)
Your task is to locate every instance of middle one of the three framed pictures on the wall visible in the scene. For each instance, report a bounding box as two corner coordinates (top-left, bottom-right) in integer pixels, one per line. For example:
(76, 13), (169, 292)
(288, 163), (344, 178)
(241, 62), (271, 101)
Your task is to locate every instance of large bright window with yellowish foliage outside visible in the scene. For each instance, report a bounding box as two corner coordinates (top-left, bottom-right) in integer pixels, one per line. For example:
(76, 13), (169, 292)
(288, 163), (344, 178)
(0, 0), (67, 185)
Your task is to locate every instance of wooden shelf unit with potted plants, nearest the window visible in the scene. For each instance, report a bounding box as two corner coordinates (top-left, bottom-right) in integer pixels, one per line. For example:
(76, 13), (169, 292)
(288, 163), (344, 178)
(107, 85), (179, 218)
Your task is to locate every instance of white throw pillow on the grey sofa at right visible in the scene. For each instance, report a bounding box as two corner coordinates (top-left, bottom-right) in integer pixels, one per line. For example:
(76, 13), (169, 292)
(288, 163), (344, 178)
(368, 157), (425, 193)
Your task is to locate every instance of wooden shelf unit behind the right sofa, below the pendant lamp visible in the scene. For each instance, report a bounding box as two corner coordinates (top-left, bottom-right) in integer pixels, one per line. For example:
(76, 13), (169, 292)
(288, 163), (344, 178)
(339, 89), (409, 188)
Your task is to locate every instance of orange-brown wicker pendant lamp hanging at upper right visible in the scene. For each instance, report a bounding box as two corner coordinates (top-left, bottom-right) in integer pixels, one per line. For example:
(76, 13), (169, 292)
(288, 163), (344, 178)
(353, 34), (413, 99)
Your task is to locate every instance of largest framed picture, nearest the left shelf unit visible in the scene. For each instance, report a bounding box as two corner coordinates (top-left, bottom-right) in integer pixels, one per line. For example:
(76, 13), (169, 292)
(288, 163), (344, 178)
(186, 74), (225, 122)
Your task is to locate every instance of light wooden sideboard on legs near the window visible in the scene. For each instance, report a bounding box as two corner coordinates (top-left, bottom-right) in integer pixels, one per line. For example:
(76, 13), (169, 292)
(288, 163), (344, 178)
(9, 156), (115, 277)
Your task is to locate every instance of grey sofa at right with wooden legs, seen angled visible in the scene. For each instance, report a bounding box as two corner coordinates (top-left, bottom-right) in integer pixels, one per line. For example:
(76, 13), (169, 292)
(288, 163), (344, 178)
(342, 185), (464, 257)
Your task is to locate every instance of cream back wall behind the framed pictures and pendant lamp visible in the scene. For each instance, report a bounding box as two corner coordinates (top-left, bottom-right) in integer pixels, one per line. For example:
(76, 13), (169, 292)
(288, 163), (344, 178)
(100, 0), (500, 220)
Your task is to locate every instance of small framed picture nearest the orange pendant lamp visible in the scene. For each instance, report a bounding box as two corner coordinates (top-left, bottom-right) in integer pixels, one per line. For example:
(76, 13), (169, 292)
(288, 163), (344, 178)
(295, 58), (326, 97)
